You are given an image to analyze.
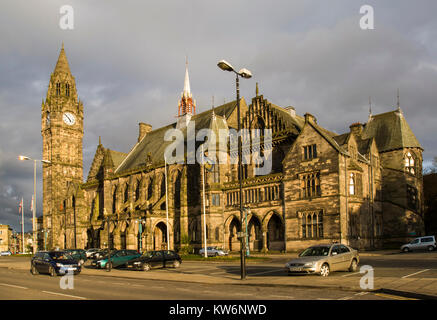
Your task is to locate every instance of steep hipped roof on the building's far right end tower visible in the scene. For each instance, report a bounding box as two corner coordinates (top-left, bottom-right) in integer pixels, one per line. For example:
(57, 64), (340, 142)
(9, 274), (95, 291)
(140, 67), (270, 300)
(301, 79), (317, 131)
(362, 109), (423, 152)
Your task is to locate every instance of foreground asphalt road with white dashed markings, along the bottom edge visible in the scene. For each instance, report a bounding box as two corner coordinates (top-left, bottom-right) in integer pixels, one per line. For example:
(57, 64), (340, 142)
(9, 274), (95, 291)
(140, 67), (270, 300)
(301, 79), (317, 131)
(0, 268), (394, 300)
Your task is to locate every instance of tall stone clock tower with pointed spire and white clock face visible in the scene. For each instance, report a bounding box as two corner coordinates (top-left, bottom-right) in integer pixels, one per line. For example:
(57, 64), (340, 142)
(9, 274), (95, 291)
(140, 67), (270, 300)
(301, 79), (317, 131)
(41, 44), (83, 249)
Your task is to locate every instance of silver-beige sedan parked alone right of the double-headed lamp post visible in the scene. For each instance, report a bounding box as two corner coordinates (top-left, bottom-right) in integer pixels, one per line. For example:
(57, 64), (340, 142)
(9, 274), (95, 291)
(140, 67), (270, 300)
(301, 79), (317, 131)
(285, 243), (360, 277)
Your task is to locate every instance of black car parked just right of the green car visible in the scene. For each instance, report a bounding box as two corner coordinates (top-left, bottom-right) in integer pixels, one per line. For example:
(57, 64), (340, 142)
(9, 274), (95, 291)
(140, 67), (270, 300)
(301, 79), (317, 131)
(128, 250), (182, 271)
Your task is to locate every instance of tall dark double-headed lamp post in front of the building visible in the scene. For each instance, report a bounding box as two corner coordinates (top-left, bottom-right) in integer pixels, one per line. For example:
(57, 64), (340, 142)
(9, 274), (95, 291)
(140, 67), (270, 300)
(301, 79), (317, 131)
(217, 60), (252, 280)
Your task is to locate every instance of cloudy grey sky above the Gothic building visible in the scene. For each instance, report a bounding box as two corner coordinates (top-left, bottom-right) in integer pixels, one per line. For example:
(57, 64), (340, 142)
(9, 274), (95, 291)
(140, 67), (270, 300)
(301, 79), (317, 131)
(0, 0), (437, 231)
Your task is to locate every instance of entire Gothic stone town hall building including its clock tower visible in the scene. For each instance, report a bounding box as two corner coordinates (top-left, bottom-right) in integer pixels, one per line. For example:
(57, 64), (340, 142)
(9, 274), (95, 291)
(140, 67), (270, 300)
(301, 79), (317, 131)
(42, 49), (423, 251)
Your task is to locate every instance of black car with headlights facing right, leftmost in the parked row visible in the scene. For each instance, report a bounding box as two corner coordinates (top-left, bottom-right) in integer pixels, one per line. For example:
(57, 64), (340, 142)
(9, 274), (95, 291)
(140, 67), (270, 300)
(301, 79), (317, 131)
(30, 251), (81, 277)
